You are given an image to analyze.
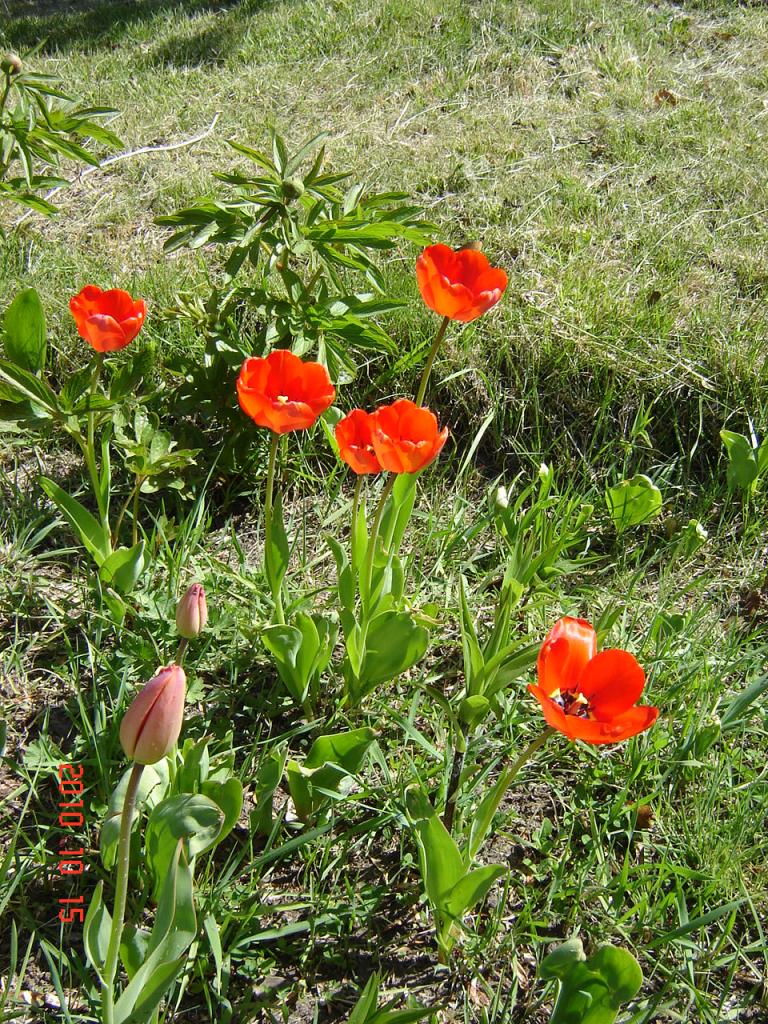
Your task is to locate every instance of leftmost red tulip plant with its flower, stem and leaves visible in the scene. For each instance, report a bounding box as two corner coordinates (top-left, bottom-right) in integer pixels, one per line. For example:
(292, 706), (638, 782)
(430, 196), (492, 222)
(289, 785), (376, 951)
(0, 285), (197, 621)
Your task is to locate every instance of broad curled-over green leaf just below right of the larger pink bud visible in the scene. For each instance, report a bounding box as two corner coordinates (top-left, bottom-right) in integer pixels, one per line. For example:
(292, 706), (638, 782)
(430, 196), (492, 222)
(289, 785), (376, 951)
(144, 794), (224, 895)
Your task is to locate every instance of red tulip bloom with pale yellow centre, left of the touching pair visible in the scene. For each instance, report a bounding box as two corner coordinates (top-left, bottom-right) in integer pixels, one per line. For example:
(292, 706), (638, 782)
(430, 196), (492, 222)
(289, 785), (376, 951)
(238, 348), (336, 434)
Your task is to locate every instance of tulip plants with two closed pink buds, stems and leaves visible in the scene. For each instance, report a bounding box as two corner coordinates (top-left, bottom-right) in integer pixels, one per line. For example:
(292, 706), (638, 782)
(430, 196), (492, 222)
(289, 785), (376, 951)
(83, 584), (243, 1024)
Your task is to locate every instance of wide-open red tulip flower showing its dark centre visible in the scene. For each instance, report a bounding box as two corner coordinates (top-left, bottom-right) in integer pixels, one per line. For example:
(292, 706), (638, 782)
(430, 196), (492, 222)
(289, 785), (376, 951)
(528, 617), (658, 743)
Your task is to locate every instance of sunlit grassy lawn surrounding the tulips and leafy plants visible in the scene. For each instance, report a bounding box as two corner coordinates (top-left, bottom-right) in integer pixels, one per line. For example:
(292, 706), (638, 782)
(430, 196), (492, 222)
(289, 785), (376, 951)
(0, 0), (768, 1024)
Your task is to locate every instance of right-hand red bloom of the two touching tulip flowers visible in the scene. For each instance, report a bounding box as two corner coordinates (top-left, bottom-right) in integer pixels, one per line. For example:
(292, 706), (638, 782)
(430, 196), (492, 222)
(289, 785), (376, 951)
(371, 398), (447, 473)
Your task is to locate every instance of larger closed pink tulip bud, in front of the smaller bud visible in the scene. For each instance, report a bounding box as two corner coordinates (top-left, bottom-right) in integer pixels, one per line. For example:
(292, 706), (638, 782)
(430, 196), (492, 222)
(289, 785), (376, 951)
(120, 665), (186, 765)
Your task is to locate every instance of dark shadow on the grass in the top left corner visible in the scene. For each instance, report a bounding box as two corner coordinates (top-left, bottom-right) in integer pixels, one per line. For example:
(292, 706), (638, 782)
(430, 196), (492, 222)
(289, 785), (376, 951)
(0, 0), (274, 57)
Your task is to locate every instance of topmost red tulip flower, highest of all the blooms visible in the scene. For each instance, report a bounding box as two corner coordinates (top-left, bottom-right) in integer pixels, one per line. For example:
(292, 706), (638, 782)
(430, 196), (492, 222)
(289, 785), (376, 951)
(416, 245), (508, 324)
